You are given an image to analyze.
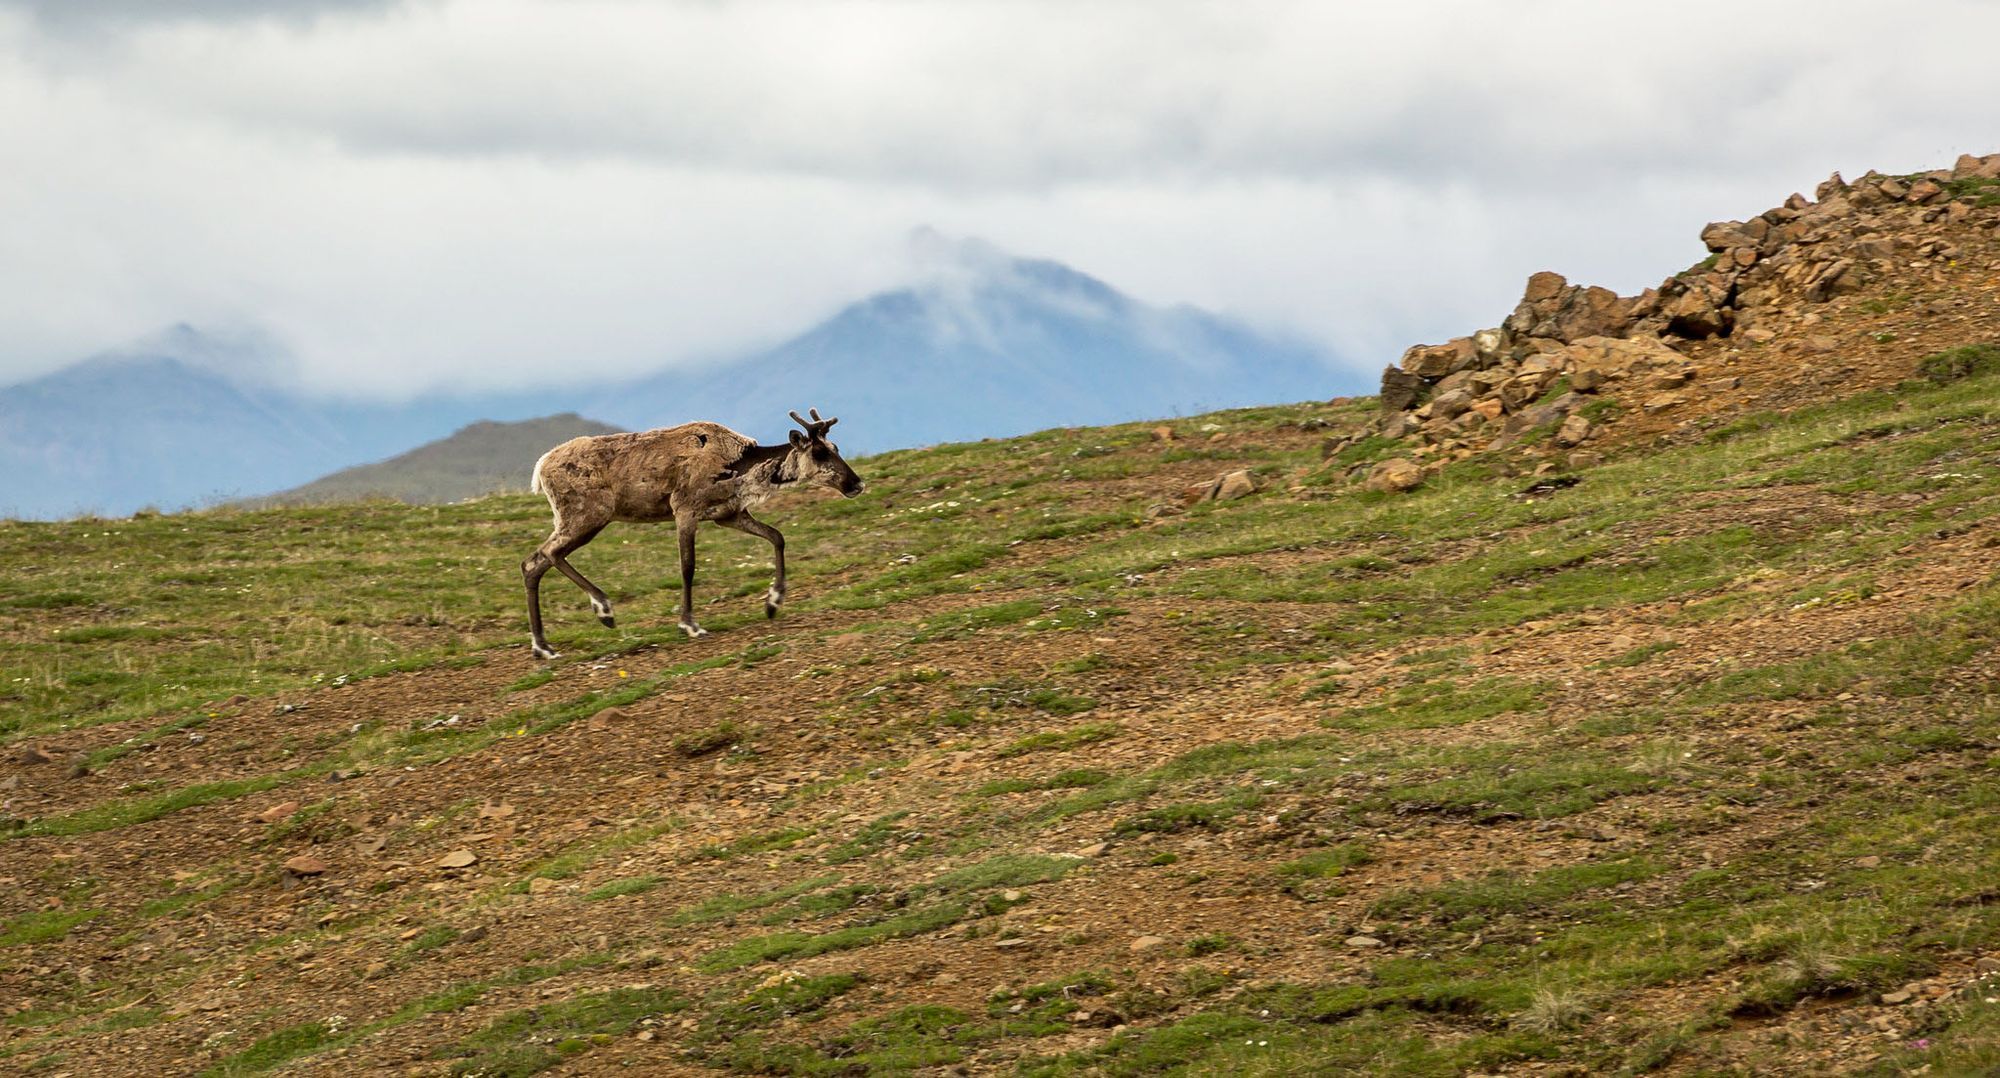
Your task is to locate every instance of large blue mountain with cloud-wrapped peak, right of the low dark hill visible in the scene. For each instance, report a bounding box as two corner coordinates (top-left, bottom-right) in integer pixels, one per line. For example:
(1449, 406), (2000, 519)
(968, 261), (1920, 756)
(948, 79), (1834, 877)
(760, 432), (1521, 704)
(580, 230), (1372, 452)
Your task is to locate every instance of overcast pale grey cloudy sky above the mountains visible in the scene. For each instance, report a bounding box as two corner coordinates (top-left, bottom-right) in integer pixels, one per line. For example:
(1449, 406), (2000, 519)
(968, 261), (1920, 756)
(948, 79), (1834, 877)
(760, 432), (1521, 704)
(0, 0), (2000, 396)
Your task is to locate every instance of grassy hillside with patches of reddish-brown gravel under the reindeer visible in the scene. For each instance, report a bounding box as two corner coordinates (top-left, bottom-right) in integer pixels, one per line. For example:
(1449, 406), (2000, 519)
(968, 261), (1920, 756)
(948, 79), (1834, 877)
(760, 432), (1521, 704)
(0, 364), (2000, 1076)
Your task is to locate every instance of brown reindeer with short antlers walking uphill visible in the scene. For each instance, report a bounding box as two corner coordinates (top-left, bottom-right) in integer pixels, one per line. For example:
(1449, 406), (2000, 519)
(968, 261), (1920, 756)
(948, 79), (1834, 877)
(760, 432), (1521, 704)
(520, 408), (862, 658)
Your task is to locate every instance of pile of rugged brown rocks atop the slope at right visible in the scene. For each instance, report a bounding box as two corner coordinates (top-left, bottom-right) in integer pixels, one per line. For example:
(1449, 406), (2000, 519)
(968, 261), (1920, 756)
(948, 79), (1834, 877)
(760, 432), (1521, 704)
(1366, 154), (2000, 468)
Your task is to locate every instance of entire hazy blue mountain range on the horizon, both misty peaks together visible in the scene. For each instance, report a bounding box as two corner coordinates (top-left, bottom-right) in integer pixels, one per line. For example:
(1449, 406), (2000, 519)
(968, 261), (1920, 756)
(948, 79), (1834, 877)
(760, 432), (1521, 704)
(0, 240), (1374, 518)
